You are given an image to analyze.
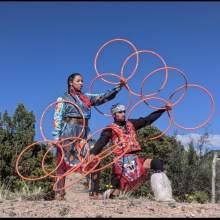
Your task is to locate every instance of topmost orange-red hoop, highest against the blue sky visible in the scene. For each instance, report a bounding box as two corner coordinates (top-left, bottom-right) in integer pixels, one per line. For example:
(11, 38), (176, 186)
(94, 38), (139, 85)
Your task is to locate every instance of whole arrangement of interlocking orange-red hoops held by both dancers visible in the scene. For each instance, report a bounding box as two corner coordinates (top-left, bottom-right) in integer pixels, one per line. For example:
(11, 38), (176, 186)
(16, 38), (215, 191)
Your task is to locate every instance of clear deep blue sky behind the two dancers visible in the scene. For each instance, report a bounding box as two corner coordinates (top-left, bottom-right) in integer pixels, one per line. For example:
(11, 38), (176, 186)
(0, 2), (220, 148)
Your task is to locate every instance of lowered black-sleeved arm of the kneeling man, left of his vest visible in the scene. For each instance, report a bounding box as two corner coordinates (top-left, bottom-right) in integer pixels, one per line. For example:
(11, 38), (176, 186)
(90, 129), (112, 155)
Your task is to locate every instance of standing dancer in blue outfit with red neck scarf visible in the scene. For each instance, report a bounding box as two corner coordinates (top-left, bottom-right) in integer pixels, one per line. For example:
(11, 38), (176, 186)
(53, 73), (124, 200)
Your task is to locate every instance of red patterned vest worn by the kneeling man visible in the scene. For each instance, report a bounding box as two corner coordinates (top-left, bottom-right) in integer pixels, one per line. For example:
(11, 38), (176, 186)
(108, 121), (141, 155)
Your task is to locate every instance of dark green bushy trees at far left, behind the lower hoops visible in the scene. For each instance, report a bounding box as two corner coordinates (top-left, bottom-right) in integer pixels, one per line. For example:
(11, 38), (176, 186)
(0, 104), (54, 199)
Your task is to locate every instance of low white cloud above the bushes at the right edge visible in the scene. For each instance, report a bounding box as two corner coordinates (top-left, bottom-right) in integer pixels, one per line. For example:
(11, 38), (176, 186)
(176, 133), (220, 153)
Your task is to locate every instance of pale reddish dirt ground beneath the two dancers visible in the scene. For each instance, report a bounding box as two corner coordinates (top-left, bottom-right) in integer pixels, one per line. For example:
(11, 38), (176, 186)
(0, 174), (220, 218)
